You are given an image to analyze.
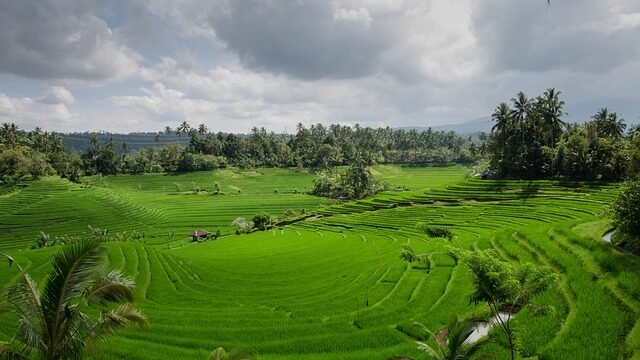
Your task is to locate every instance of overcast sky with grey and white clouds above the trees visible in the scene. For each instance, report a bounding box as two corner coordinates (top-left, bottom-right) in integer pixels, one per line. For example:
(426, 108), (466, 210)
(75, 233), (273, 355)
(0, 0), (640, 133)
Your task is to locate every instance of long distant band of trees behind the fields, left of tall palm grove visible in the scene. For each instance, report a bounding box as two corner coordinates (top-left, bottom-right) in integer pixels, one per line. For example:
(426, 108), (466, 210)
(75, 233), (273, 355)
(0, 122), (482, 183)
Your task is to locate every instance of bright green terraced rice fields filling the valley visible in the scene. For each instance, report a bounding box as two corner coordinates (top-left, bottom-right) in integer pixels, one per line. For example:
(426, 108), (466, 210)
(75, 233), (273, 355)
(0, 167), (640, 359)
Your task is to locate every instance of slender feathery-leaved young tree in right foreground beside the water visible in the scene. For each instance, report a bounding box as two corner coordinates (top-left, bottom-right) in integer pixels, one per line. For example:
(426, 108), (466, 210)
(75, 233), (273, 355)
(451, 248), (558, 359)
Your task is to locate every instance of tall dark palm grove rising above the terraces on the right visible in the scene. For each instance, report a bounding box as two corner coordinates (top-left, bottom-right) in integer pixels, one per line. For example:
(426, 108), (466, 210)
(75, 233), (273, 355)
(488, 89), (640, 180)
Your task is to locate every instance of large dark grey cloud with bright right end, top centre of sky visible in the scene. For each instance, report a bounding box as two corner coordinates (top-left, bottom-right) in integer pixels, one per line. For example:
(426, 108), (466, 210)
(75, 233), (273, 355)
(149, 0), (481, 82)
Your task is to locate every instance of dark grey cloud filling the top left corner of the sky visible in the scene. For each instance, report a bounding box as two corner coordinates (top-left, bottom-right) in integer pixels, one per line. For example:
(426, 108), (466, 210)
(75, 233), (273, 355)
(0, 0), (141, 81)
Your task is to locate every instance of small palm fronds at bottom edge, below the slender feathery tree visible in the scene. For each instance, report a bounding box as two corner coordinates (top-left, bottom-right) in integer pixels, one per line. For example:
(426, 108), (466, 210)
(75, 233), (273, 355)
(415, 318), (489, 360)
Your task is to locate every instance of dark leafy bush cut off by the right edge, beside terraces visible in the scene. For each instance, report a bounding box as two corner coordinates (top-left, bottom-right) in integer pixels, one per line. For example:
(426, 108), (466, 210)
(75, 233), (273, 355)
(611, 180), (640, 254)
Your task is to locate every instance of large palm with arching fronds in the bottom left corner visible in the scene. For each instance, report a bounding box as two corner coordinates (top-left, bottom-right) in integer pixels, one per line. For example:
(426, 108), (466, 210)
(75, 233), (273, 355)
(0, 240), (147, 360)
